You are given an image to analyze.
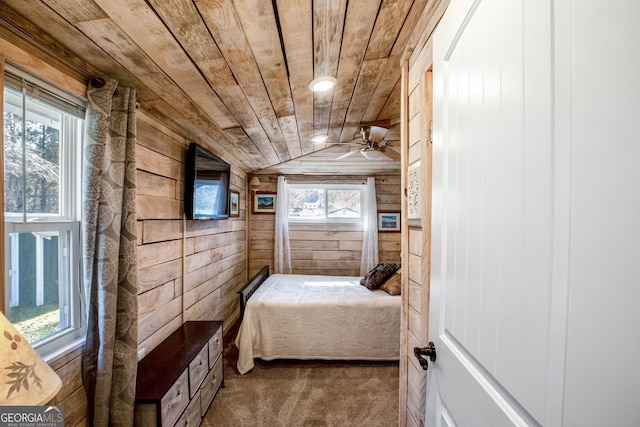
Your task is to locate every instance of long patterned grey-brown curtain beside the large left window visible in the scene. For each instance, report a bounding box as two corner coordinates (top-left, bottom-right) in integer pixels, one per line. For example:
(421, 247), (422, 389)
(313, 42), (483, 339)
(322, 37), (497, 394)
(82, 79), (138, 426)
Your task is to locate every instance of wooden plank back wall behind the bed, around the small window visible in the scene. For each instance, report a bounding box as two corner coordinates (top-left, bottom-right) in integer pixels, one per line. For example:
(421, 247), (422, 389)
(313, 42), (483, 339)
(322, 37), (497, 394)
(249, 175), (400, 276)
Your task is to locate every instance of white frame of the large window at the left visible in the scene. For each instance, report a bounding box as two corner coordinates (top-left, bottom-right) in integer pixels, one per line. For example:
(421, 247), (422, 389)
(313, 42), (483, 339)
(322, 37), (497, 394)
(2, 64), (86, 360)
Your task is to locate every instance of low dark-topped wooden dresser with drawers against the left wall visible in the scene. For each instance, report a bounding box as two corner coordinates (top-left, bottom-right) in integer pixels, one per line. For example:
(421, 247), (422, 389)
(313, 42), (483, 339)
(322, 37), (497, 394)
(135, 321), (224, 427)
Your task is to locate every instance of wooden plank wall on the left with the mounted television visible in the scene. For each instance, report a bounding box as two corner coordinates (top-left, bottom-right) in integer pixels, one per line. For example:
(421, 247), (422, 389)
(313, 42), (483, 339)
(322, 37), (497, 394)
(136, 113), (247, 353)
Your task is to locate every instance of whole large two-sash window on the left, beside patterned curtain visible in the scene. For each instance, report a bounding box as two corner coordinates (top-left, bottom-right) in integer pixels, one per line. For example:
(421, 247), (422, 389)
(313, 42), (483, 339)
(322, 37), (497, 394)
(4, 66), (84, 356)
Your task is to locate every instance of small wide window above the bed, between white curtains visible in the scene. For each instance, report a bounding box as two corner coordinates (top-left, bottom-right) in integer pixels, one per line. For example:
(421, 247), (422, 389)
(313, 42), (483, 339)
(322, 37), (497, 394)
(288, 184), (364, 222)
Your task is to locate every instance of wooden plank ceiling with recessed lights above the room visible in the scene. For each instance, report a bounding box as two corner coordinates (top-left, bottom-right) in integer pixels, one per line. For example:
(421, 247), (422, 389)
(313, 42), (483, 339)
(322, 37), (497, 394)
(0, 0), (434, 175)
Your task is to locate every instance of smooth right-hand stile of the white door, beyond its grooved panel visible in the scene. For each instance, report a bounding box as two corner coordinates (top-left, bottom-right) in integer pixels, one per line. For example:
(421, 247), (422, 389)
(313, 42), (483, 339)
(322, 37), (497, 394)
(550, 1), (640, 426)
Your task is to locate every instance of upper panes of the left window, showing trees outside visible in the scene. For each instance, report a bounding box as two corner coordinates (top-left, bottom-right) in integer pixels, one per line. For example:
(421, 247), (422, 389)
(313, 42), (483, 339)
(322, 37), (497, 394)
(4, 88), (62, 215)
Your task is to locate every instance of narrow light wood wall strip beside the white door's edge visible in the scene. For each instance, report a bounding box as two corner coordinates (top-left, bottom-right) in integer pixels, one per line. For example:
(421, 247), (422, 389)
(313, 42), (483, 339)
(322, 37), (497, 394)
(399, 4), (449, 426)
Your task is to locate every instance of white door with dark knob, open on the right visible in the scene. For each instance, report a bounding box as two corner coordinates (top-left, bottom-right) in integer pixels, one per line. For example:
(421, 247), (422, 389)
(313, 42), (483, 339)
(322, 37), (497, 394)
(426, 0), (640, 427)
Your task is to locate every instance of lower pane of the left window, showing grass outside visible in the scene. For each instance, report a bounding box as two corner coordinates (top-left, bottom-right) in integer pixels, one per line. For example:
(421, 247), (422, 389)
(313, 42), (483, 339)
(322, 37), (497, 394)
(9, 231), (70, 343)
